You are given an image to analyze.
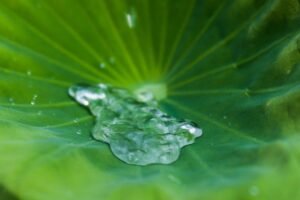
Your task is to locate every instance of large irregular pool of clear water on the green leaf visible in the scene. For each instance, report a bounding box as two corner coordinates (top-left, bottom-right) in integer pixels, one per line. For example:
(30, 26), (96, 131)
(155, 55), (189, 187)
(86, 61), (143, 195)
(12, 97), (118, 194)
(69, 84), (202, 165)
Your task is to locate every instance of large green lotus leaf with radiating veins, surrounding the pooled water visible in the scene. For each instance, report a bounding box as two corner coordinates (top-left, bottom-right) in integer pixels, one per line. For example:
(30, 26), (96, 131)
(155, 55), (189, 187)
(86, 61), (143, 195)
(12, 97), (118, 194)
(0, 0), (300, 200)
